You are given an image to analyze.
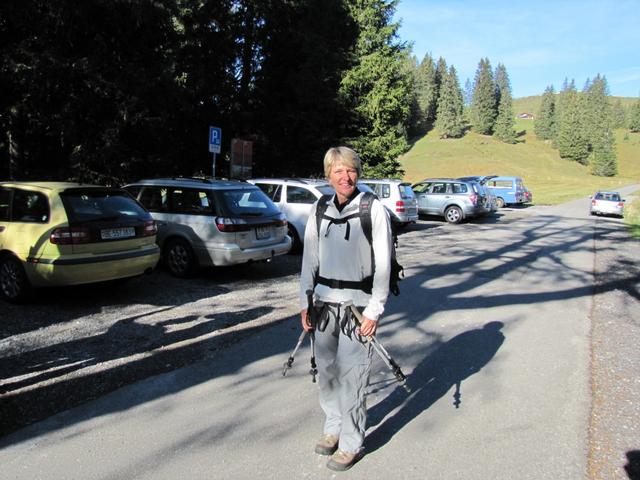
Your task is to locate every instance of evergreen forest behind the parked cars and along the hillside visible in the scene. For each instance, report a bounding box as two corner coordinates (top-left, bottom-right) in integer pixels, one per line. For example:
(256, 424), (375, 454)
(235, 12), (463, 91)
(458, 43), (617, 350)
(0, 0), (640, 184)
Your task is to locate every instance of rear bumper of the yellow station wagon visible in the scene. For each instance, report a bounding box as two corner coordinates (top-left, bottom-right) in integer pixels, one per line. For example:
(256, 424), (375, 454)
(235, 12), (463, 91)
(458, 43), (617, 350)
(24, 248), (160, 287)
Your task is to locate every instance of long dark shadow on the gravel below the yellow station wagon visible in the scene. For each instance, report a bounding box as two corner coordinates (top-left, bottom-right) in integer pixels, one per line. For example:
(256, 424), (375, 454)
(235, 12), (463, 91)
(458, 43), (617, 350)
(0, 307), (273, 436)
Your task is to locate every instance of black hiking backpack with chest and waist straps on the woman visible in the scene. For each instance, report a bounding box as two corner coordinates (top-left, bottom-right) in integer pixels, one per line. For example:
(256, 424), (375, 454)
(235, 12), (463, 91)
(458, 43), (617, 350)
(316, 192), (404, 296)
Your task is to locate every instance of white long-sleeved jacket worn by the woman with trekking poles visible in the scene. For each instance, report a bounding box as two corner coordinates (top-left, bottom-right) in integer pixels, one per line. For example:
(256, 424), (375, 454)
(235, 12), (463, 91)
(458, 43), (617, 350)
(300, 193), (392, 320)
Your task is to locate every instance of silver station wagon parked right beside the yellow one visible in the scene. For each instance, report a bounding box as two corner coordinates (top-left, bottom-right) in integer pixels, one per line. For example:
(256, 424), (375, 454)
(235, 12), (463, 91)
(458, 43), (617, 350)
(124, 178), (291, 277)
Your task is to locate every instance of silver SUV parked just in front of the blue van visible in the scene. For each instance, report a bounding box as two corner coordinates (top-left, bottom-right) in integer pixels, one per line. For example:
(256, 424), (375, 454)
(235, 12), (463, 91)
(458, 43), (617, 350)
(412, 178), (489, 223)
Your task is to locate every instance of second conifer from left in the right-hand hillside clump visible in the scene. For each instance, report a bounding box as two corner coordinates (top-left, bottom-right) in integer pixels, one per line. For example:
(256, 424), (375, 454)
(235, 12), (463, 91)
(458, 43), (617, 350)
(555, 81), (589, 164)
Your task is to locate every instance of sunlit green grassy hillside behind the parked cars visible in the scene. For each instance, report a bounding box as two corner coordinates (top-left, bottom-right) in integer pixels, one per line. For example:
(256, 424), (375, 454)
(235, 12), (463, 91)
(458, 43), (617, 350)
(400, 97), (640, 205)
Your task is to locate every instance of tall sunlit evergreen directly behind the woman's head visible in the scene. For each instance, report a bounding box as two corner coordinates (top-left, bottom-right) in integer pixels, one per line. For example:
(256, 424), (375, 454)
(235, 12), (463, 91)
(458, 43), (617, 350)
(340, 0), (413, 177)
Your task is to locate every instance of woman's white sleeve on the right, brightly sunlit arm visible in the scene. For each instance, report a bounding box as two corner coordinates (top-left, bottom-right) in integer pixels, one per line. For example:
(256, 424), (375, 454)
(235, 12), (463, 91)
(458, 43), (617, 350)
(362, 200), (393, 320)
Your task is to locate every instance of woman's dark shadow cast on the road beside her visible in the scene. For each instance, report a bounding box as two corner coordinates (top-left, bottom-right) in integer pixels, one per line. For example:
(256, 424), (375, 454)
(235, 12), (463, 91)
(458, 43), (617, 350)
(365, 322), (504, 452)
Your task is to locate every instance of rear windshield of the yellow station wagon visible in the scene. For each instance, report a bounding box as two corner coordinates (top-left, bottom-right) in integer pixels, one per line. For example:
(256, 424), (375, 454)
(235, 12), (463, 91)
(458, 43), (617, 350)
(60, 188), (149, 223)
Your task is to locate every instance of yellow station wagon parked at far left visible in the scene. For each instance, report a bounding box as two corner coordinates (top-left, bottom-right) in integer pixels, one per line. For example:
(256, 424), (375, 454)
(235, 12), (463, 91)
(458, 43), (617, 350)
(0, 182), (160, 302)
